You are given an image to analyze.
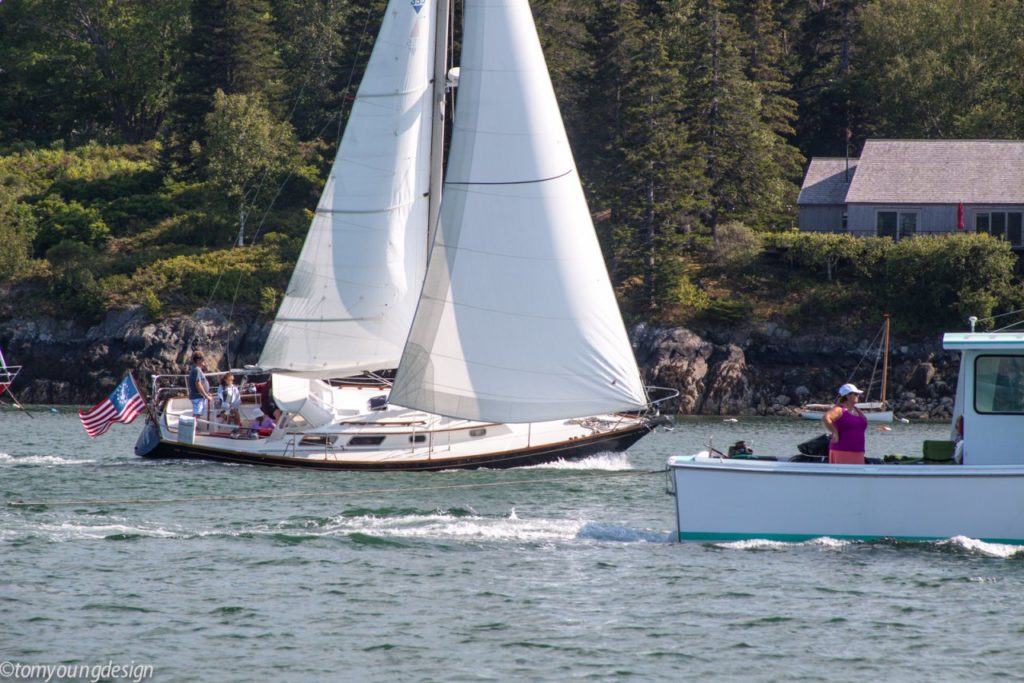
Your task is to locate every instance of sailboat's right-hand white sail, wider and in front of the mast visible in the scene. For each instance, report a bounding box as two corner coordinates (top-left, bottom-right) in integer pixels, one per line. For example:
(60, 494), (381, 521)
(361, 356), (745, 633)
(390, 0), (647, 423)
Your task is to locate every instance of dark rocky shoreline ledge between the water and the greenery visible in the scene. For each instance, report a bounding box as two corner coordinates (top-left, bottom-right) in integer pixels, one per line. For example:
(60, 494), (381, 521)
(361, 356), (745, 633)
(0, 308), (959, 420)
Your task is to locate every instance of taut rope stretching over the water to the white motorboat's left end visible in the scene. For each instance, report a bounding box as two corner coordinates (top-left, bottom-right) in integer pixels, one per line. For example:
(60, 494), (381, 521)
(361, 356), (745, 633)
(7, 468), (668, 508)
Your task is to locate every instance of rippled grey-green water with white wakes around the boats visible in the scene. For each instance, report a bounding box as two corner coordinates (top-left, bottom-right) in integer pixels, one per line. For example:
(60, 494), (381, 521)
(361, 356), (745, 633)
(0, 410), (1024, 681)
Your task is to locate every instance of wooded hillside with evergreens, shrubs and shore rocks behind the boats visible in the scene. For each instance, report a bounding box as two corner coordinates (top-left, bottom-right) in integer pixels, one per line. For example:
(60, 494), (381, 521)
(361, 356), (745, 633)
(0, 0), (1024, 415)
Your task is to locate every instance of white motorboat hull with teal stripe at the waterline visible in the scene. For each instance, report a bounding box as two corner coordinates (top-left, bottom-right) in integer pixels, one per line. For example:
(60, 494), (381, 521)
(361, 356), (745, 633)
(669, 456), (1024, 544)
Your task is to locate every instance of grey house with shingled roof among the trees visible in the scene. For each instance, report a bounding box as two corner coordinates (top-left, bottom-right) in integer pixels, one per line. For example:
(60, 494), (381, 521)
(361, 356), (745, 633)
(797, 140), (1024, 247)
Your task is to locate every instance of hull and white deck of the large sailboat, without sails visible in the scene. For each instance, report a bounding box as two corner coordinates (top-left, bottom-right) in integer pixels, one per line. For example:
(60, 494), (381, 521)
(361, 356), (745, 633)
(136, 388), (650, 470)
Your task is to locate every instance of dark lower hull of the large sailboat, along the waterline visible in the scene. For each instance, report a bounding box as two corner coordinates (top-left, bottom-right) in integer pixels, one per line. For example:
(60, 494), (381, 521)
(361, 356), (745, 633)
(135, 421), (654, 472)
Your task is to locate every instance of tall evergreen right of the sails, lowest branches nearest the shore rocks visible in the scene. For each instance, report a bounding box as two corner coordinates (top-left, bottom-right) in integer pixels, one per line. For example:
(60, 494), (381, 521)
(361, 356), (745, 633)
(599, 0), (706, 312)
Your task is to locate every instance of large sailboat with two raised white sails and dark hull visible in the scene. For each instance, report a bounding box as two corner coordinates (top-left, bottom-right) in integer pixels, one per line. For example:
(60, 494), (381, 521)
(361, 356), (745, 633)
(135, 0), (660, 470)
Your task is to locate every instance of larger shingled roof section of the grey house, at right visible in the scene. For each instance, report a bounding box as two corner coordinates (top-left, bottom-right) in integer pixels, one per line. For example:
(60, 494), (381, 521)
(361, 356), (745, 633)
(843, 140), (1024, 204)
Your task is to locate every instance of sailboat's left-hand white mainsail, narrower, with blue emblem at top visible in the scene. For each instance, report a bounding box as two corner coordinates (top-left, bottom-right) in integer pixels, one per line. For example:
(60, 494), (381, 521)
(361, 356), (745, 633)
(259, 0), (435, 378)
